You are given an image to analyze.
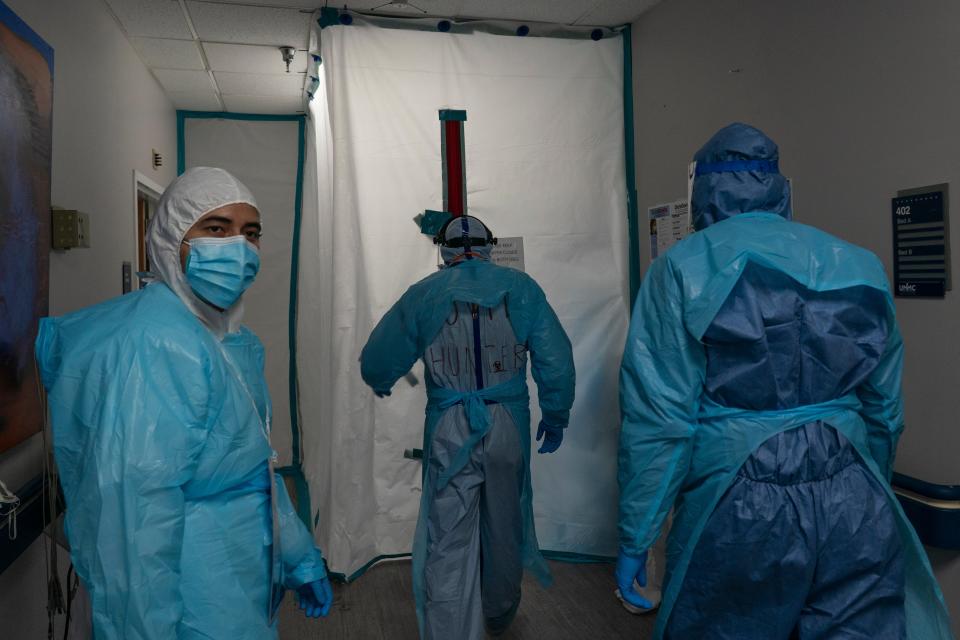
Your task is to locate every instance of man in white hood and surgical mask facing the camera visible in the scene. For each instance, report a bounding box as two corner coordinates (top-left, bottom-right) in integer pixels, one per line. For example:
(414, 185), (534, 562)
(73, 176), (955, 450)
(36, 167), (333, 640)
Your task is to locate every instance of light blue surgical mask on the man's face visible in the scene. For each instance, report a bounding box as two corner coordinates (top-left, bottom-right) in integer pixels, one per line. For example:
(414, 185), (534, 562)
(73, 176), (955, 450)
(184, 236), (260, 309)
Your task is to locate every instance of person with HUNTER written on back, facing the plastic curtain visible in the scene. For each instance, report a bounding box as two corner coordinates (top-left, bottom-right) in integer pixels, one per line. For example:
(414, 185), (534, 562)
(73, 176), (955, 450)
(360, 216), (574, 640)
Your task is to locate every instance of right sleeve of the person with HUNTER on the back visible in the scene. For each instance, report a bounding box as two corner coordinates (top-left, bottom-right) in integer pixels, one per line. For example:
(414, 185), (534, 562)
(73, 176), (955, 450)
(527, 287), (576, 428)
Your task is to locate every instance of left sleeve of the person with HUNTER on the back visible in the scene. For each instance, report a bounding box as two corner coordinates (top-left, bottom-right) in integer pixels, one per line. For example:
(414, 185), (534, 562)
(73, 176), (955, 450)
(360, 289), (422, 394)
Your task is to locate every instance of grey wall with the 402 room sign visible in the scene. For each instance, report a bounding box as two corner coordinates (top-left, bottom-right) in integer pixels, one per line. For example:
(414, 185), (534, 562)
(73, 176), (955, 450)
(633, 0), (960, 631)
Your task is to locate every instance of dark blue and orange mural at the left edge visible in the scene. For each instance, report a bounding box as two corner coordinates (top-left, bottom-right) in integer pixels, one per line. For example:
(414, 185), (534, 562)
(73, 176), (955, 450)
(0, 1), (53, 451)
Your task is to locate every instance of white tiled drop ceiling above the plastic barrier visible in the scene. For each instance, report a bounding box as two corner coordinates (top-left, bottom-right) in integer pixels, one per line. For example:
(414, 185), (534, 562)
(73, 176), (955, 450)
(104, 0), (660, 113)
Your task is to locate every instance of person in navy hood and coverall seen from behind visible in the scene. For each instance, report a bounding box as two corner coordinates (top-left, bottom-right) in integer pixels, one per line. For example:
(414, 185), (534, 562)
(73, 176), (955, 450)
(616, 124), (952, 640)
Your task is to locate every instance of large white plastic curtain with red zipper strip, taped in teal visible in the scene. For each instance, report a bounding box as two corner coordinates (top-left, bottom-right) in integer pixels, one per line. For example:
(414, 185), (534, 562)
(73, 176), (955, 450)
(298, 23), (629, 576)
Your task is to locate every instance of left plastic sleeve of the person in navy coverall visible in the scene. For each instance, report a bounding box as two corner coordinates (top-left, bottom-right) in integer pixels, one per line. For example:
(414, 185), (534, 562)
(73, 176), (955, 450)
(619, 258), (706, 555)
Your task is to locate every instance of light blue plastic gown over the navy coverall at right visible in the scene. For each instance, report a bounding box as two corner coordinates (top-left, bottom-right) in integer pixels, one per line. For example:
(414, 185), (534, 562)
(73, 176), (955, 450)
(620, 213), (952, 640)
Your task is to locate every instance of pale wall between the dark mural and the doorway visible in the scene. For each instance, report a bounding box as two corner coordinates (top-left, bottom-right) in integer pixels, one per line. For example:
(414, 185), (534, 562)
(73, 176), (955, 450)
(0, 0), (176, 638)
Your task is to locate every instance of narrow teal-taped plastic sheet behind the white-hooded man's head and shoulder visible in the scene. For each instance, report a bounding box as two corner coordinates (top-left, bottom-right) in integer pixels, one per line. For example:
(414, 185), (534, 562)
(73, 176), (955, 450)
(182, 118), (299, 466)
